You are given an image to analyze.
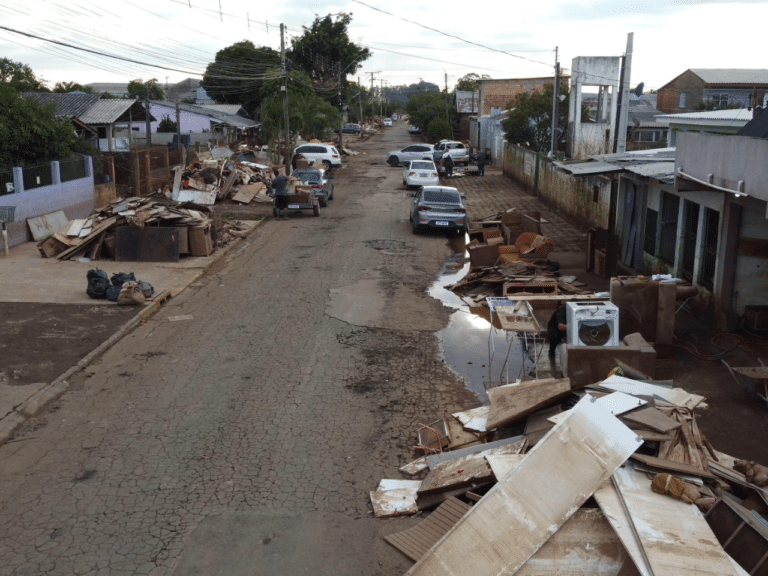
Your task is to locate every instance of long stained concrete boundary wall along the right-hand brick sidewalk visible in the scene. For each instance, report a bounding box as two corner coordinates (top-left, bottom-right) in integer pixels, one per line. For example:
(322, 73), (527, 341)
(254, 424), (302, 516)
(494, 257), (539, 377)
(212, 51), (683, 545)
(503, 144), (610, 230)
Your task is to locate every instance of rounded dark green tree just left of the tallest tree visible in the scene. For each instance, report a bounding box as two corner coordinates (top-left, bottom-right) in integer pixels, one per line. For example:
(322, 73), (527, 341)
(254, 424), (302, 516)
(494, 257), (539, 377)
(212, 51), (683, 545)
(200, 40), (282, 113)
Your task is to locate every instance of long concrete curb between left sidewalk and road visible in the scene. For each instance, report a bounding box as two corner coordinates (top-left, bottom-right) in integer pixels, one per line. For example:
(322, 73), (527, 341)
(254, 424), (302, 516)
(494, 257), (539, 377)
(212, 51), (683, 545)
(0, 218), (268, 446)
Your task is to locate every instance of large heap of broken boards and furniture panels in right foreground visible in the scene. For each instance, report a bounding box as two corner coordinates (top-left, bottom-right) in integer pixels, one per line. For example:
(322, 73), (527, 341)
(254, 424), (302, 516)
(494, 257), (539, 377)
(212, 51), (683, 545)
(371, 369), (768, 576)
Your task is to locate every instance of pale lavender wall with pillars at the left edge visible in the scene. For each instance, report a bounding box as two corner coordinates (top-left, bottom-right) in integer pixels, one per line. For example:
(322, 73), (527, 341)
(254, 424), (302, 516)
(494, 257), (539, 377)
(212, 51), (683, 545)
(0, 156), (94, 246)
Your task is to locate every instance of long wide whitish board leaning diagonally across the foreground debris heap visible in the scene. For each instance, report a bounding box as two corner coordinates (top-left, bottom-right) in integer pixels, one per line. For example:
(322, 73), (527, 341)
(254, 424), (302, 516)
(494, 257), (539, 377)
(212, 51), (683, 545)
(407, 399), (641, 576)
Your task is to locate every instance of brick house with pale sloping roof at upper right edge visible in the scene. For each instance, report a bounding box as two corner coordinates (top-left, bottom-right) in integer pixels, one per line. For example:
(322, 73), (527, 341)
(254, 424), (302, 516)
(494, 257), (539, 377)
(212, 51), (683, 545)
(657, 68), (768, 114)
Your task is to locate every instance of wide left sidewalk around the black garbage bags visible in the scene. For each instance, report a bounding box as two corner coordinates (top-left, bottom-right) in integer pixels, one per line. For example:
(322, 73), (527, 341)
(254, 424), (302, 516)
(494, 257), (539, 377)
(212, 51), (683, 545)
(0, 220), (264, 444)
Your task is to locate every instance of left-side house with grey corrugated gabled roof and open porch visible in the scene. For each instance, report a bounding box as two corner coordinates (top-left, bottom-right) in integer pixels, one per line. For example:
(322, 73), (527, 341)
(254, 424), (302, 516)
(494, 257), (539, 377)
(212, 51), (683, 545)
(22, 92), (154, 152)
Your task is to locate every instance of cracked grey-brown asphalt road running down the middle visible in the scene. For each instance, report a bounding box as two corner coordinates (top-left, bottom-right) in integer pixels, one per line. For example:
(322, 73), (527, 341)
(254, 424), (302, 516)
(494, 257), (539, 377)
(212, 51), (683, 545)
(0, 124), (477, 576)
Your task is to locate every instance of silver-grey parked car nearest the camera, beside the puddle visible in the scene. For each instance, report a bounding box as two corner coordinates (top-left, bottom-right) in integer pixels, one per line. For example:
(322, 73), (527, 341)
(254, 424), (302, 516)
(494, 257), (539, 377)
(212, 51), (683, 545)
(408, 186), (467, 234)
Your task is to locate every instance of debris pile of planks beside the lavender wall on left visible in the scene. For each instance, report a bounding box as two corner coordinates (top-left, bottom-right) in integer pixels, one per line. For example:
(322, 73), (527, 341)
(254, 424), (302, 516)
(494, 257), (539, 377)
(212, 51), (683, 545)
(37, 194), (245, 262)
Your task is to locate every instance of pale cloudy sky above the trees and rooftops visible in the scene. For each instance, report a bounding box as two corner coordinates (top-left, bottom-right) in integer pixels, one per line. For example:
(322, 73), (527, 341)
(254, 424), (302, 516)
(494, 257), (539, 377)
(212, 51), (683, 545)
(0, 0), (768, 91)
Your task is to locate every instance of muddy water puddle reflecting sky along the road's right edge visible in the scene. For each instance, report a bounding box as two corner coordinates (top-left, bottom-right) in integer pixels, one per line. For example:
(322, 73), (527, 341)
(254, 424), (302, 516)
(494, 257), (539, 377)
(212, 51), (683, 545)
(427, 246), (546, 403)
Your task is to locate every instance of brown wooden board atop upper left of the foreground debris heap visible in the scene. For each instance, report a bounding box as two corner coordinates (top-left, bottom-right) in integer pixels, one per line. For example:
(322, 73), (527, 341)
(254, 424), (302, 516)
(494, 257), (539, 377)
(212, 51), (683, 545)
(486, 378), (571, 430)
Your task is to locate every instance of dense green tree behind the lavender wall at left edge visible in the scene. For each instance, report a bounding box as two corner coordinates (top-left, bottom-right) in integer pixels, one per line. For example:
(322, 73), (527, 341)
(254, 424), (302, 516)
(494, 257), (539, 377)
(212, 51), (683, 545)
(0, 82), (77, 171)
